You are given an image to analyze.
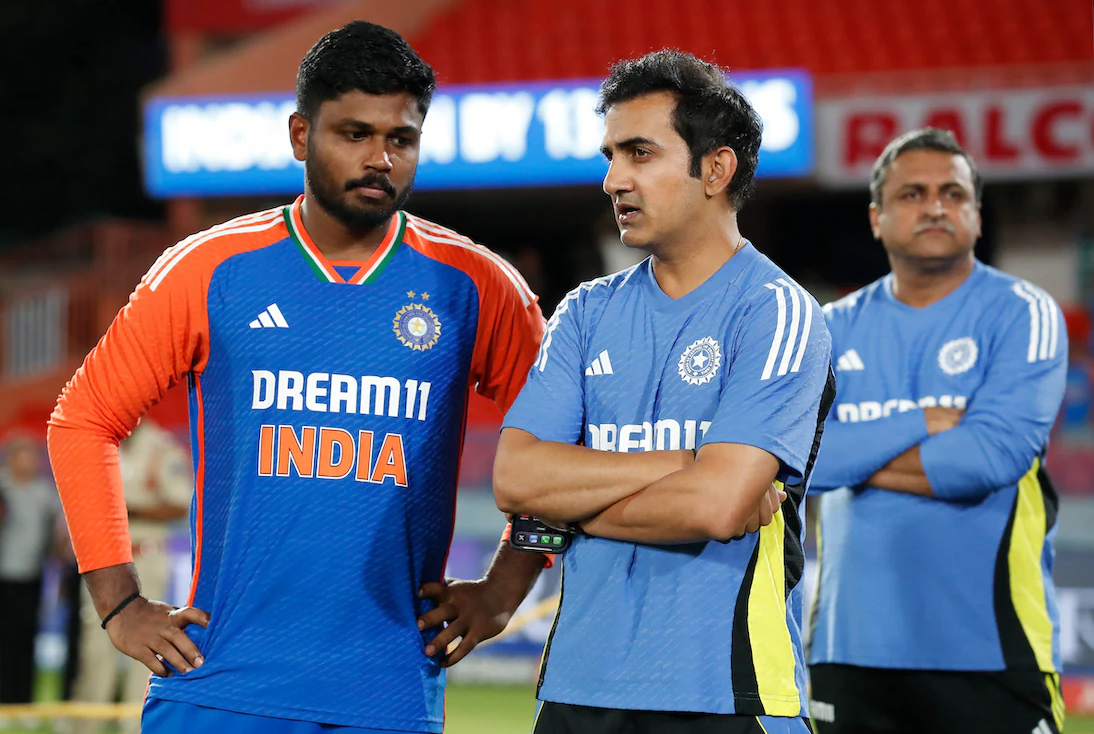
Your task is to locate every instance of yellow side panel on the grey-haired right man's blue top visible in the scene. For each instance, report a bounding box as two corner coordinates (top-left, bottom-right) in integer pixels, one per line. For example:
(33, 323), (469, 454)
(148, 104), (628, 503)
(1006, 458), (1056, 673)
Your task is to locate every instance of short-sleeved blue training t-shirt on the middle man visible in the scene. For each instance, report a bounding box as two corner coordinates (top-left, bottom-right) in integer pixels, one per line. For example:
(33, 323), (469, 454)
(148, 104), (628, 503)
(504, 244), (830, 716)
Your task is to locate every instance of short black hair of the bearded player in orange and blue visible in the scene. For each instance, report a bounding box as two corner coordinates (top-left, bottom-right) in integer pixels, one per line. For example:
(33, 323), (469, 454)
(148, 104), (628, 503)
(296, 21), (437, 119)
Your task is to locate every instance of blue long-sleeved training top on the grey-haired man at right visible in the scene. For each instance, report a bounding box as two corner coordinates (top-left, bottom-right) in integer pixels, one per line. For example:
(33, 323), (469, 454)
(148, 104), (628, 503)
(810, 263), (1068, 673)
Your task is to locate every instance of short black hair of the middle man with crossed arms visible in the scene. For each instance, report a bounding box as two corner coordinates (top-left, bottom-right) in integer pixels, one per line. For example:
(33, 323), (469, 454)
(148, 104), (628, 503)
(596, 48), (764, 211)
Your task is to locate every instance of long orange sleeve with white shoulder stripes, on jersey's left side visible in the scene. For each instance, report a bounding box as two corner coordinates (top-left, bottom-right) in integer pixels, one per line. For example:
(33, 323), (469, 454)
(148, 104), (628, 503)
(47, 208), (287, 573)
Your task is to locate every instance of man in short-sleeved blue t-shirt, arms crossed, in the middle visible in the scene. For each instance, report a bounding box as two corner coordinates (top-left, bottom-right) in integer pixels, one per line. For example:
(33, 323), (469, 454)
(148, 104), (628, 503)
(494, 50), (831, 734)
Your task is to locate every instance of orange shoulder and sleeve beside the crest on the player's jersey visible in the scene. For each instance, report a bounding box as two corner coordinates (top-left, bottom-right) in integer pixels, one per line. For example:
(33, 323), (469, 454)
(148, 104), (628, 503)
(405, 214), (545, 413)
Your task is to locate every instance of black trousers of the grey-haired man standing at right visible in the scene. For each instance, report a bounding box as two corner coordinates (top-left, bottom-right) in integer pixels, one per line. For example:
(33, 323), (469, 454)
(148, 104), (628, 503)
(810, 664), (1063, 734)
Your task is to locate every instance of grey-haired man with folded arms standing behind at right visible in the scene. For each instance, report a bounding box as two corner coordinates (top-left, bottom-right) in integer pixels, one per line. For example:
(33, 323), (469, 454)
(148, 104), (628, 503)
(810, 128), (1068, 734)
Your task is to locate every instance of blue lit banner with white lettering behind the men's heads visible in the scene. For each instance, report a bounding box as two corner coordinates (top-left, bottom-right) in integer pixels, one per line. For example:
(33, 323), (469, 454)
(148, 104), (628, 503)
(144, 71), (813, 198)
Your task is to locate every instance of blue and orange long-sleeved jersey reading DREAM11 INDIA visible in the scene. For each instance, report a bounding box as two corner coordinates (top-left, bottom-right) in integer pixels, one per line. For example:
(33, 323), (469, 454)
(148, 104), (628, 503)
(49, 198), (543, 732)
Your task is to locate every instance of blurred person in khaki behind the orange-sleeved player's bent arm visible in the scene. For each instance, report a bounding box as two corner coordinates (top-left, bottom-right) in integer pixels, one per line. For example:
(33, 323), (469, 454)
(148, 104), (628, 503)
(73, 417), (194, 732)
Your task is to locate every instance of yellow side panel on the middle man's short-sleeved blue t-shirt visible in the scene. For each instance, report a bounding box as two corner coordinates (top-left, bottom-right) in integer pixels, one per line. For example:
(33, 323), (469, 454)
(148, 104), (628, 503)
(748, 487), (802, 716)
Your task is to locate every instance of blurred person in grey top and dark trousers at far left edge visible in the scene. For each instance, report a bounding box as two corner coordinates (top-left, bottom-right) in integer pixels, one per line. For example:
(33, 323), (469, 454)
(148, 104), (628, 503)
(0, 434), (60, 703)
